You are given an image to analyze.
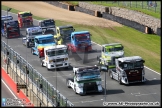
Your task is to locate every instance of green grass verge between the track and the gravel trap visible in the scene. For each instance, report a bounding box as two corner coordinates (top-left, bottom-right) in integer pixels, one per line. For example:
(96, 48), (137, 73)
(2, 6), (161, 73)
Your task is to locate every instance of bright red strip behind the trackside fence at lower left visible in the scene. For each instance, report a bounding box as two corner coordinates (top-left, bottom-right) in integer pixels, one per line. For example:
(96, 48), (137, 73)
(1, 68), (34, 107)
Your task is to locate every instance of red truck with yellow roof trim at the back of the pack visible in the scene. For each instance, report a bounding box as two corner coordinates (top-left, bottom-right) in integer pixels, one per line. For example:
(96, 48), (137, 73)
(18, 11), (33, 28)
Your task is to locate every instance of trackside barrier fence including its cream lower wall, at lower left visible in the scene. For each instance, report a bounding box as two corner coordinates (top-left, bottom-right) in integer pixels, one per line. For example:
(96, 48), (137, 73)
(1, 41), (74, 107)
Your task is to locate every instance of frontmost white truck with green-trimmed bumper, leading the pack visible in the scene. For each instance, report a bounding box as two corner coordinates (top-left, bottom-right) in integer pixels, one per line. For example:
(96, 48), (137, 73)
(66, 66), (103, 95)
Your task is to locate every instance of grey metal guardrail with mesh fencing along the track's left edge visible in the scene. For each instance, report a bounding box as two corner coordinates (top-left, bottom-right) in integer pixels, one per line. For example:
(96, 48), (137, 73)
(1, 41), (74, 107)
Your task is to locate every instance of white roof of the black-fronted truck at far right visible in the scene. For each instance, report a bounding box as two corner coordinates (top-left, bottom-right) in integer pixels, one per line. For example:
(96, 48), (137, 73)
(118, 56), (143, 62)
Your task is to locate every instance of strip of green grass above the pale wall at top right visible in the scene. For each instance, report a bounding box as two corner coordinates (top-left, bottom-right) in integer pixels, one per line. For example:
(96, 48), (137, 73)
(66, 1), (161, 19)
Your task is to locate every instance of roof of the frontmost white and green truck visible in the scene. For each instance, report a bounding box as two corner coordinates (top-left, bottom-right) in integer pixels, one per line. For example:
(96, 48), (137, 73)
(74, 66), (99, 73)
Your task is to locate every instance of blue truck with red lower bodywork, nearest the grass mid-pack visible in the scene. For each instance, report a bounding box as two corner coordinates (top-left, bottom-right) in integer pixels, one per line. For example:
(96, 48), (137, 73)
(67, 31), (92, 53)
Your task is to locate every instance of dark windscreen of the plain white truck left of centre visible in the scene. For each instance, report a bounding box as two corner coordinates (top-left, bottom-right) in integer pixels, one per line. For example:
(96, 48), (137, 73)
(47, 49), (67, 57)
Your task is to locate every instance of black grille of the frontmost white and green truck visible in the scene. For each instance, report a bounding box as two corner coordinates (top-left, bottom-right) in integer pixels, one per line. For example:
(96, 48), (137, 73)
(83, 82), (98, 93)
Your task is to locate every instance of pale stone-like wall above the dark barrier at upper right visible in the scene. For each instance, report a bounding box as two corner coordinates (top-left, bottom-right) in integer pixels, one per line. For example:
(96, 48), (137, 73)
(79, 2), (161, 34)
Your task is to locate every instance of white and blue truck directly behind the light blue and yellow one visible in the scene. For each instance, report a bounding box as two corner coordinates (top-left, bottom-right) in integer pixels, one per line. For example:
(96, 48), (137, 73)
(22, 27), (43, 48)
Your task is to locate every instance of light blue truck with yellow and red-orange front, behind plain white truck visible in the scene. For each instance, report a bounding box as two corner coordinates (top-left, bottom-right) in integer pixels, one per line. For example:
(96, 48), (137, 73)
(31, 34), (56, 58)
